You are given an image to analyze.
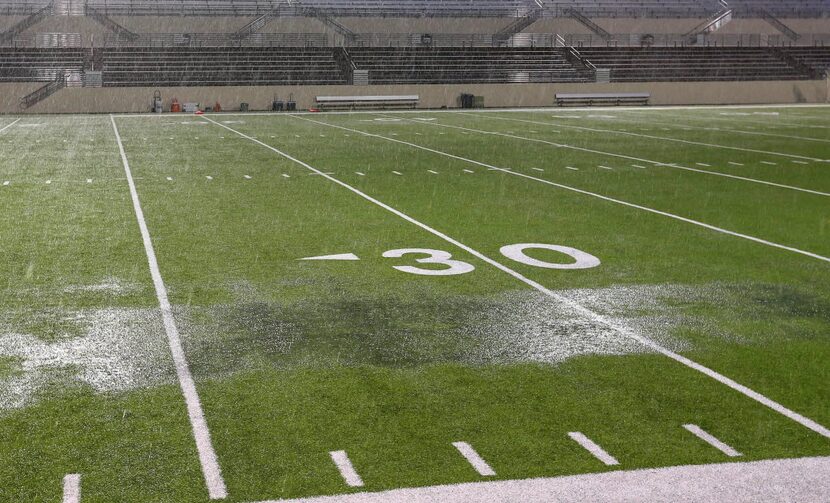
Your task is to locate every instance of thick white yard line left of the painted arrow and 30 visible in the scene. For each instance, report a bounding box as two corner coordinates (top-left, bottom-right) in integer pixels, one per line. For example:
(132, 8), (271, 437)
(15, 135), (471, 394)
(110, 115), (228, 499)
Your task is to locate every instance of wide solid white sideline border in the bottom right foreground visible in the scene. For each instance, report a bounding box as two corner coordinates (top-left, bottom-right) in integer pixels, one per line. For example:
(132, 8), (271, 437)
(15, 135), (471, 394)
(245, 457), (830, 503)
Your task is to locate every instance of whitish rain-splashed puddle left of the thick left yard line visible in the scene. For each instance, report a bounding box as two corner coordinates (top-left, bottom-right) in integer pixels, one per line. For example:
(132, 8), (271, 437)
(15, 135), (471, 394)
(0, 308), (176, 410)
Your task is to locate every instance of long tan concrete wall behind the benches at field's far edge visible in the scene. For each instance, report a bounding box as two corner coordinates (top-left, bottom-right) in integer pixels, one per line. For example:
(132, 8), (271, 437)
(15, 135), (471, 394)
(0, 80), (828, 114)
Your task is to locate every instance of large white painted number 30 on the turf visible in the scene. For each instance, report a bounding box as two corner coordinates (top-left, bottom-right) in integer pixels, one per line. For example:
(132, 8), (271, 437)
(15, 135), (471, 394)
(383, 243), (600, 276)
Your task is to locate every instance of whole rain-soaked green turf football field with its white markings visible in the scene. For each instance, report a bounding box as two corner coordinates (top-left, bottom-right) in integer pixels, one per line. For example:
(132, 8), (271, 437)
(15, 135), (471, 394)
(0, 107), (830, 503)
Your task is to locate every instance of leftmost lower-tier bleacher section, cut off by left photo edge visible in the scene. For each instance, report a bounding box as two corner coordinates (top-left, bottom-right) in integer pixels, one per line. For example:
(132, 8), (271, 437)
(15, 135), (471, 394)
(0, 47), (85, 82)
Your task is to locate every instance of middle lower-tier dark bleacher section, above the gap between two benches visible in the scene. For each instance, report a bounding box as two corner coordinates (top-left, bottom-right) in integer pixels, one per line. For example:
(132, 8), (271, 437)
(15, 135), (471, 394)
(349, 47), (590, 84)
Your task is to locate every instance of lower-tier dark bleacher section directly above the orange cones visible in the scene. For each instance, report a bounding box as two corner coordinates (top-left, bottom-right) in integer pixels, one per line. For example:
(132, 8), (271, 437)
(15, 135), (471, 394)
(101, 47), (347, 87)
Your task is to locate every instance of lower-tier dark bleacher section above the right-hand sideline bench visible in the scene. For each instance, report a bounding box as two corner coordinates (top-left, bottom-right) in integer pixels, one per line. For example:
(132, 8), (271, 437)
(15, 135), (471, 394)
(579, 47), (810, 82)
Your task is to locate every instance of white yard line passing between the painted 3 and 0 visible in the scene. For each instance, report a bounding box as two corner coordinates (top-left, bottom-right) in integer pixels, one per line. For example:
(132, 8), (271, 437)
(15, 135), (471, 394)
(202, 116), (830, 438)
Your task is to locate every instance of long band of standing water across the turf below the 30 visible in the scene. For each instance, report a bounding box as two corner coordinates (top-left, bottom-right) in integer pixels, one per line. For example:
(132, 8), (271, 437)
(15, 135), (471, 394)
(0, 280), (830, 411)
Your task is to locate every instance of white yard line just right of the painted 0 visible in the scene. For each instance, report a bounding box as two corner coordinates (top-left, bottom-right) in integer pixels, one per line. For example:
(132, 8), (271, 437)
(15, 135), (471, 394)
(295, 113), (830, 262)
